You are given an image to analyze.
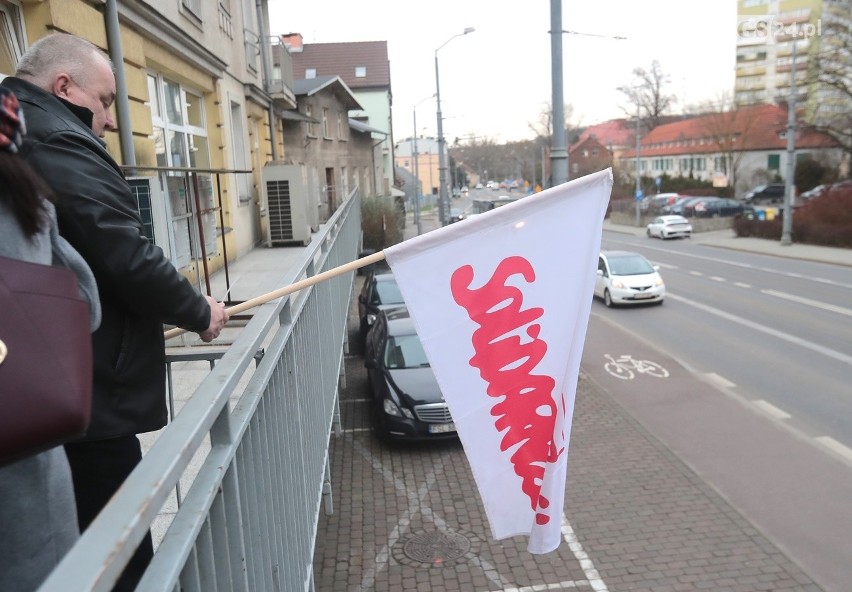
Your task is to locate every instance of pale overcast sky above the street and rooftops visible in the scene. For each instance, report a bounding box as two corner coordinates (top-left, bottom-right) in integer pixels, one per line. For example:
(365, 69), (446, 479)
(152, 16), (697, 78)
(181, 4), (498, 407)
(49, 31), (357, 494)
(269, 0), (737, 142)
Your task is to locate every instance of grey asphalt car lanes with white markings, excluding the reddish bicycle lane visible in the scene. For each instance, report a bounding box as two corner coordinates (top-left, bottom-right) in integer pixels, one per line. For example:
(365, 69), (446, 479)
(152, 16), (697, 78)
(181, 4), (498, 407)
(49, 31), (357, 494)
(597, 234), (852, 448)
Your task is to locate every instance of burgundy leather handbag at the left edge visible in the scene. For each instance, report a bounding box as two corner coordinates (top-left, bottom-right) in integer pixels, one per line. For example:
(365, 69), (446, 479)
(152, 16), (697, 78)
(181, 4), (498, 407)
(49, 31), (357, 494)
(0, 257), (92, 466)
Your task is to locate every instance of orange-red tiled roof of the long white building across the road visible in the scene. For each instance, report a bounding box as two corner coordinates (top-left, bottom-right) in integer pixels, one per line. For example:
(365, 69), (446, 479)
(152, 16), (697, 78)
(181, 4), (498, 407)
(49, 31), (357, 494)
(623, 105), (837, 157)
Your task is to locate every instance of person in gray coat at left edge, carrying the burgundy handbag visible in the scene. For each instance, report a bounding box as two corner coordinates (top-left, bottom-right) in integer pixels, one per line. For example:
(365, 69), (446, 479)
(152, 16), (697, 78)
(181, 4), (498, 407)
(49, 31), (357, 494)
(0, 87), (101, 592)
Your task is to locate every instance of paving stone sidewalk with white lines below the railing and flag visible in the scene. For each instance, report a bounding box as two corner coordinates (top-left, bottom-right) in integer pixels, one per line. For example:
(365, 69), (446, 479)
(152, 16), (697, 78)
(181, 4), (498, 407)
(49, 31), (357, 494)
(314, 268), (820, 592)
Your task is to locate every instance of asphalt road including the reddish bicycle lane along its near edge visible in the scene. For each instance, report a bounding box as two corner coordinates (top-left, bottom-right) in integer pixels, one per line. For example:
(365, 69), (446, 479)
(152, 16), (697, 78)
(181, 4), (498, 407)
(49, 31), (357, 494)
(583, 233), (852, 590)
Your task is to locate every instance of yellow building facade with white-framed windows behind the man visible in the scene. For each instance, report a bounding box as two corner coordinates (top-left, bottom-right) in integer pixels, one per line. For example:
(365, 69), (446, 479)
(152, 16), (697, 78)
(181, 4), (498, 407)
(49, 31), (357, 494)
(0, 0), (295, 284)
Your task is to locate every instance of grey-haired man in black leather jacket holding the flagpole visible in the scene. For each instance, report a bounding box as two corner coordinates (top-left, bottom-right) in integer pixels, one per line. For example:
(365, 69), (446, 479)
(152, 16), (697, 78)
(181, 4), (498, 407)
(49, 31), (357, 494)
(0, 33), (228, 590)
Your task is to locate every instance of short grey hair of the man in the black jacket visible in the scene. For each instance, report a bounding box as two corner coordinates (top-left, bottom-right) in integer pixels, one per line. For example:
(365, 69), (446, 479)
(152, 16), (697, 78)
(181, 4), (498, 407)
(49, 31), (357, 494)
(15, 33), (115, 90)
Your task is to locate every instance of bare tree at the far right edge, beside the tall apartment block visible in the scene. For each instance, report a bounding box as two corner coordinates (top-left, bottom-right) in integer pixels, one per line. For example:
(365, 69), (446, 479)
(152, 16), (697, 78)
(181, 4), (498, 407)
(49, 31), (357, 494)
(808, 2), (852, 171)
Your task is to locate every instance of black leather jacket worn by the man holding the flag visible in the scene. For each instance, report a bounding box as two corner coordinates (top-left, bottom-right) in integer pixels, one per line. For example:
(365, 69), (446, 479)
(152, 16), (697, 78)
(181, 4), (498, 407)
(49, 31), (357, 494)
(2, 78), (210, 440)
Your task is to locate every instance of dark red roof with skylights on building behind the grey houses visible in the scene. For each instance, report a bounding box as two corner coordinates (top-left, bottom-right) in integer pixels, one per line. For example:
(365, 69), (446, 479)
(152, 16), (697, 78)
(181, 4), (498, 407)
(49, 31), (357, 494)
(291, 41), (390, 90)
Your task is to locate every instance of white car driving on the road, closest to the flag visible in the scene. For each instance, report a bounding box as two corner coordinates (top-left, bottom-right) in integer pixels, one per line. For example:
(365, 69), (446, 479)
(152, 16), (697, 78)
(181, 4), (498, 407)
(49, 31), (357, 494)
(595, 251), (666, 307)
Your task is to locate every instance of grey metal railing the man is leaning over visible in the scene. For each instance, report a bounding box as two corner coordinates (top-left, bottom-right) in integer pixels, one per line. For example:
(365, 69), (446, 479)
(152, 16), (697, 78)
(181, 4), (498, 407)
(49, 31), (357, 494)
(39, 190), (361, 592)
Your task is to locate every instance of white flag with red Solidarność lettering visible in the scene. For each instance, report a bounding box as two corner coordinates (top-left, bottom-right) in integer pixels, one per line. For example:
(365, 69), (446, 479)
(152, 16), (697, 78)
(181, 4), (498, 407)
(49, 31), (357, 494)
(385, 169), (612, 553)
